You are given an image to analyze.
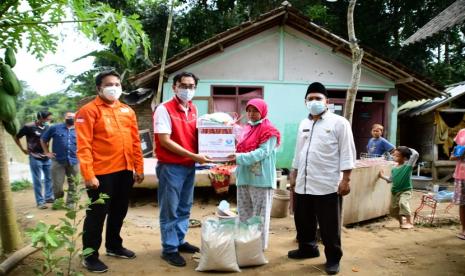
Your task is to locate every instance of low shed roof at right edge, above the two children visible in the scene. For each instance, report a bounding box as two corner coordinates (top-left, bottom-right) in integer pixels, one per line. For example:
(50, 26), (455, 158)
(398, 81), (465, 117)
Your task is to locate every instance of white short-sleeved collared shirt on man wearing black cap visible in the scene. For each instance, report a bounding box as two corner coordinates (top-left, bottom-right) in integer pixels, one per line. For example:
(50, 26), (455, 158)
(292, 111), (356, 195)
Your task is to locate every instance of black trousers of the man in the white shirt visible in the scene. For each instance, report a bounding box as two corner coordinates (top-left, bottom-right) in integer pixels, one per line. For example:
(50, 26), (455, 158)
(294, 193), (342, 263)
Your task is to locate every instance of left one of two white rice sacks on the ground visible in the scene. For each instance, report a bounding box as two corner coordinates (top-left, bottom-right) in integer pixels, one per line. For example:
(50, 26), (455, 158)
(195, 219), (241, 272)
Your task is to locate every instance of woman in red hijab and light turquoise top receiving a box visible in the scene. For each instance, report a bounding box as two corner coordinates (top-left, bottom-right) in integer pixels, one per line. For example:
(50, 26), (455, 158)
(227, 99), (281, 249)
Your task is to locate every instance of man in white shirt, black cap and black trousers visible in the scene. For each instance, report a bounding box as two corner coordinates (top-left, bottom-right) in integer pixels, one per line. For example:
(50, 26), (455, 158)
(288, 82), (356, 274)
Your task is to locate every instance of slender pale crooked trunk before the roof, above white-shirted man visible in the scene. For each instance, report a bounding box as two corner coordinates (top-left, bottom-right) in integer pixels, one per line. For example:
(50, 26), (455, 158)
(344, 0), (363, 124)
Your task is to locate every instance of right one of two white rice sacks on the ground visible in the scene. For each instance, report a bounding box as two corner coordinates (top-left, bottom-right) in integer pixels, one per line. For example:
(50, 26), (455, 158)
(234, 217), (268, 267)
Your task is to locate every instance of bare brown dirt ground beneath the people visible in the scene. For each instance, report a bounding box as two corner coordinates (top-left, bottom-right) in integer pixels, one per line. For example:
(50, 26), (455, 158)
(3, 189), (465, 276)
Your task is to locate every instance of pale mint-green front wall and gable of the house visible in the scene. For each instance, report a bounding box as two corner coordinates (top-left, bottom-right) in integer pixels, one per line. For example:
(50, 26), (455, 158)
(163, 24), (397, 168)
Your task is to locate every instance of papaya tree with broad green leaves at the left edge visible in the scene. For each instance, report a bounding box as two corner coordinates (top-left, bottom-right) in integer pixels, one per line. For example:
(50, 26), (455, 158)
(0, 0), (149, 252)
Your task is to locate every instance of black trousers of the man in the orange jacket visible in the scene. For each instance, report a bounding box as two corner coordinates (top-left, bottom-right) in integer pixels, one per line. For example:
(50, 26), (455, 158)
(82, 170), (134, 256)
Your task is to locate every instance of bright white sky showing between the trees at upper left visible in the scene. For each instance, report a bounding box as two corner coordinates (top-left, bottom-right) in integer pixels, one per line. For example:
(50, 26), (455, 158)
(13, 24), (104, 95)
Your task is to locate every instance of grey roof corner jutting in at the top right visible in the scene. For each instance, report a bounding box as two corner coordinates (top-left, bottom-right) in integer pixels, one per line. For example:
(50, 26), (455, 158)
(402, 0), (465, 45)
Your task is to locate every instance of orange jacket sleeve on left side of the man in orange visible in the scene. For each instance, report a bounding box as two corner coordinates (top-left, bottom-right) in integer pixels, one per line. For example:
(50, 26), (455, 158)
(75, 106), (97, 180)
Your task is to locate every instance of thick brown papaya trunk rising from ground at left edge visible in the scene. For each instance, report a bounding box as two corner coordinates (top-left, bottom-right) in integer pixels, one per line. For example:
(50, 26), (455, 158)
(0, 122), (22, 253)
